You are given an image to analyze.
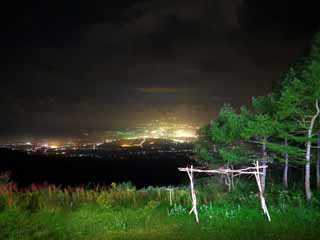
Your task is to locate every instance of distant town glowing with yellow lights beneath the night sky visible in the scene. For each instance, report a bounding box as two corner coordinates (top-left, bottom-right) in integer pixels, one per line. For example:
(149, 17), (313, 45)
(0, 120), (198, 156)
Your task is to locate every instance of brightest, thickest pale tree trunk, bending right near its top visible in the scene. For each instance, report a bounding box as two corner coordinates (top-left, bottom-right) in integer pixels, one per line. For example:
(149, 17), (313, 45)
(304, 100), (320, 201)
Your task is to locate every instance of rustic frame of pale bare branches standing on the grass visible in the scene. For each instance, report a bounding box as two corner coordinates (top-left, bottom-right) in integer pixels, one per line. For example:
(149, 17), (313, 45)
(178, 161), (271, 222)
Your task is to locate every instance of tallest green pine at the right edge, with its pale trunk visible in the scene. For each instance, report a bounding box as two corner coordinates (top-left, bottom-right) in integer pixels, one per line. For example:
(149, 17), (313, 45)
(278, 34), (320, 200)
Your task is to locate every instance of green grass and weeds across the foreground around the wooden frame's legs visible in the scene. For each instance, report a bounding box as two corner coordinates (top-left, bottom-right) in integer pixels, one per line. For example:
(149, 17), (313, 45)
(0, 181), (320, 240)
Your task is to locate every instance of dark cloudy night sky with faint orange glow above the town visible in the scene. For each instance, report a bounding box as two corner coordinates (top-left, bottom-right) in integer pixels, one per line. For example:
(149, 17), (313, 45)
(0, 0), (320, 137)
